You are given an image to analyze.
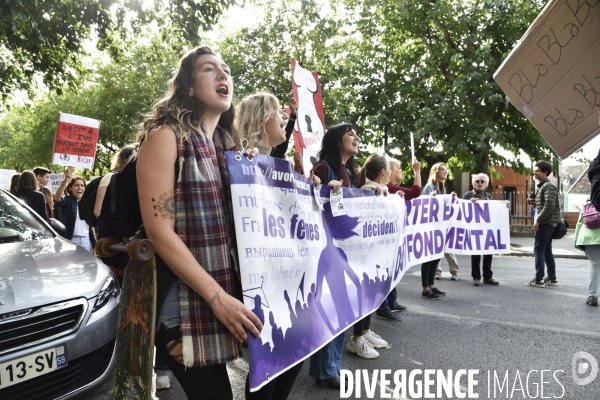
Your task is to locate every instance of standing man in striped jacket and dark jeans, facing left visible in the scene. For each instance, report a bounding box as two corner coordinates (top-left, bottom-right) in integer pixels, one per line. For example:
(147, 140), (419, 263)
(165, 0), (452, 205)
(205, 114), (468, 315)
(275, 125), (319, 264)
(525, 161), (560, 288)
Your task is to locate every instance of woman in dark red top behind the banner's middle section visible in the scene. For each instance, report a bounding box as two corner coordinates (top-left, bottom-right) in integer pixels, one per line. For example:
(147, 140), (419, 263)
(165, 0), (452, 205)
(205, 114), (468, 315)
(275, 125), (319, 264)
(376, 158), (421, 320)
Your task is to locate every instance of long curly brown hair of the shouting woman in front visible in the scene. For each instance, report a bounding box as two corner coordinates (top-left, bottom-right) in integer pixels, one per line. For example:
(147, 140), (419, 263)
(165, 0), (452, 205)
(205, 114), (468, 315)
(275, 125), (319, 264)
(138, 46), (240, 148)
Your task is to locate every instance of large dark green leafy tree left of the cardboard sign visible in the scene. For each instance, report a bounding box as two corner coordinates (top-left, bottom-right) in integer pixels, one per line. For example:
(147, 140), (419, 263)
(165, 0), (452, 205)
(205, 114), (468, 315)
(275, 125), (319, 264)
(346, 0), (551, 173)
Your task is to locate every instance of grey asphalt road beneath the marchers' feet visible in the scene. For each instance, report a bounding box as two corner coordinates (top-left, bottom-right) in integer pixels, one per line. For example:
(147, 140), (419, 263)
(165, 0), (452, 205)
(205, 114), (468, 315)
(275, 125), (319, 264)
(81, 256), (600, 400)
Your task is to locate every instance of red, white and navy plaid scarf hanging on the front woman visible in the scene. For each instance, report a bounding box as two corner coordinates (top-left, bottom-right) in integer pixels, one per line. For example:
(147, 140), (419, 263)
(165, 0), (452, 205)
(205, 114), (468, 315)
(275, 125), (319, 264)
(172, 126), (242, 367)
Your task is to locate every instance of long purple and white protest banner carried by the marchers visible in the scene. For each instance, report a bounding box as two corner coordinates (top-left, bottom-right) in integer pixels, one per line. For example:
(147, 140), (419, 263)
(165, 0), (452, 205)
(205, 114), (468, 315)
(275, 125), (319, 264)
(227, 152), (510, 391)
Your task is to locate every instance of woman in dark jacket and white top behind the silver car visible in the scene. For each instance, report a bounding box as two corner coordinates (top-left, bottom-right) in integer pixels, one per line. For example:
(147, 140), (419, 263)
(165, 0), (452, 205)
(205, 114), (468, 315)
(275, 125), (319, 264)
(54, 169), (96, 252)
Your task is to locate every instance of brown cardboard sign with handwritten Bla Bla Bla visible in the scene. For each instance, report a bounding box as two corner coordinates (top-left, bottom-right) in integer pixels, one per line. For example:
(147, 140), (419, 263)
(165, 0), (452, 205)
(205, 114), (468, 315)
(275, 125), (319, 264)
(494, 0), (600, 158)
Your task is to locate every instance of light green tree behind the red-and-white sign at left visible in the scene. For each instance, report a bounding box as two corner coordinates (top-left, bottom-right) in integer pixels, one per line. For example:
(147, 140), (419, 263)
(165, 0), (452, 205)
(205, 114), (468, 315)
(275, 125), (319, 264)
(0, 37), (182, 175)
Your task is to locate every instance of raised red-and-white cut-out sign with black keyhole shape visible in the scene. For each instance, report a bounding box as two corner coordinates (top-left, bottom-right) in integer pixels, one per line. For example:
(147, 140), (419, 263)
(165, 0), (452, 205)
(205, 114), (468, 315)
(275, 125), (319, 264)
(291, 59), (325, 175)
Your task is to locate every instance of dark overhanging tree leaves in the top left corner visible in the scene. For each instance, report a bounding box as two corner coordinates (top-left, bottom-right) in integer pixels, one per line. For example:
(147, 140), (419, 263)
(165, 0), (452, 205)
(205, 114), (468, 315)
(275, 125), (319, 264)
(0, 0), (235, 100)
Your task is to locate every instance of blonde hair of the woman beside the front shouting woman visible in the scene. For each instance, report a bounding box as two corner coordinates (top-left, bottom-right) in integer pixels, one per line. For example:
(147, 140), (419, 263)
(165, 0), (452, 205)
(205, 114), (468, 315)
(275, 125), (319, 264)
(235, 92), (280, 148)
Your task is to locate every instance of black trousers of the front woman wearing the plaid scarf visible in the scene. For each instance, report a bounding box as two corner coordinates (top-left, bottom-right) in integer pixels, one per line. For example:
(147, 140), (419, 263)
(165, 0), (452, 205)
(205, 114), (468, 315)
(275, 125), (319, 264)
(154, 324), (303, 400)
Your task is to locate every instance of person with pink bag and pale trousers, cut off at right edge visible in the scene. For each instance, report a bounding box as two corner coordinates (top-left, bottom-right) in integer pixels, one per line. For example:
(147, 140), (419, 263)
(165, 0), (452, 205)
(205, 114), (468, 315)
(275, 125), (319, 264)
(575, 103), (600, 307)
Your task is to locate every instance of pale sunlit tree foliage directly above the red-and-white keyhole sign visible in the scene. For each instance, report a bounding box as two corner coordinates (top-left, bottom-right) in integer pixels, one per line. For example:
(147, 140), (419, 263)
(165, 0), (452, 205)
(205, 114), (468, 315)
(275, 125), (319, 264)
(218, 0), (354, 125)
